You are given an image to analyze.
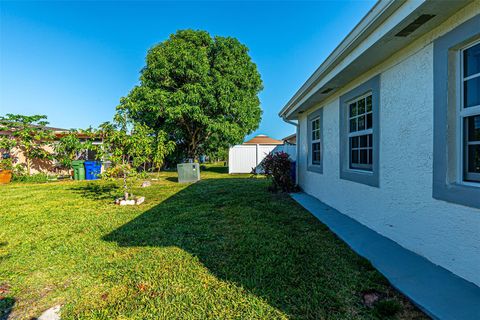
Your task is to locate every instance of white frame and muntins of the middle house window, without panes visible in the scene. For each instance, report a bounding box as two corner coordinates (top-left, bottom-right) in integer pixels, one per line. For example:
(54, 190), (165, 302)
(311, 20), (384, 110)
(346, 91), (374, 172)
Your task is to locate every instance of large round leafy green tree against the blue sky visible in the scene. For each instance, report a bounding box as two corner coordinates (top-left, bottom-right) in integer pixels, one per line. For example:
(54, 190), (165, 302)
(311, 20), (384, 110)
(119, 30), (262, 158)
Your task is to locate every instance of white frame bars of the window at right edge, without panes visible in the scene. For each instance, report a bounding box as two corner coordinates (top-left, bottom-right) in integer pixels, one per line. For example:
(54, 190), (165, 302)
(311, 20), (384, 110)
(457, 40), (480, 187)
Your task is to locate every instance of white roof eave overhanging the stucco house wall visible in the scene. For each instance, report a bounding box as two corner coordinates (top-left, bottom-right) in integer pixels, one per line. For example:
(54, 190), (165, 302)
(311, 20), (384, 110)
(279, 0), (473, 122)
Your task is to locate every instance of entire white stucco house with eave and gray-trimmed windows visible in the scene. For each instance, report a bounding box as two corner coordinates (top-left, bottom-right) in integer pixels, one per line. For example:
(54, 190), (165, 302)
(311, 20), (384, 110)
(280, 0), (480, 286)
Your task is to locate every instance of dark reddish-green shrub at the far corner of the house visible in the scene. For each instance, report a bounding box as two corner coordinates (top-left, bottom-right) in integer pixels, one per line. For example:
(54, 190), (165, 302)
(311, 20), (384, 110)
(261, 151), (295, 192)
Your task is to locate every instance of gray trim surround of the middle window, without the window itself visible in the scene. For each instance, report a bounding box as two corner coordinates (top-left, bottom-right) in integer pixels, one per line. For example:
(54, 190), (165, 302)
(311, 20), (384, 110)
(339, 75), (380, 187)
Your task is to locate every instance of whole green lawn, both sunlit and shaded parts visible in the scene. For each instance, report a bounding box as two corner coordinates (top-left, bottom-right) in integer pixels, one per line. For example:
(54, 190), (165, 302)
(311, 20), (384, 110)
(0, 167), (425, 319)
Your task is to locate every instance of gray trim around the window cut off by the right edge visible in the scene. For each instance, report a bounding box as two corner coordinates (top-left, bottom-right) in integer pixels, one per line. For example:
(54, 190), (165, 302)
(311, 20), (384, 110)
(432, 15), (480, 208)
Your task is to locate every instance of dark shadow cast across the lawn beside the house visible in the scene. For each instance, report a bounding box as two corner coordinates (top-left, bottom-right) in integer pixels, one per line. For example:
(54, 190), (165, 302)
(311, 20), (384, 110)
(104, 178), (410, 319)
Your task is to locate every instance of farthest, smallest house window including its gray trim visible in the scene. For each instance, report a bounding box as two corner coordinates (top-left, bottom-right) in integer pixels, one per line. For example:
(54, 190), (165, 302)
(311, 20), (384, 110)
(307, 108), (323, 173)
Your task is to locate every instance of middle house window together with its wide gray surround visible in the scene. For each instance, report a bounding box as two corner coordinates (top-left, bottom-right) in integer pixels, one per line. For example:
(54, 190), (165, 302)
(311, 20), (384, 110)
(340, 76), (380, 187)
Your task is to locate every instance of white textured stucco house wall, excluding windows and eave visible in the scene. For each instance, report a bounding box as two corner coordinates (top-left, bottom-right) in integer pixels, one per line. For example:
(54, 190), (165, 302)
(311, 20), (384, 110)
(297, 2), (480, 286)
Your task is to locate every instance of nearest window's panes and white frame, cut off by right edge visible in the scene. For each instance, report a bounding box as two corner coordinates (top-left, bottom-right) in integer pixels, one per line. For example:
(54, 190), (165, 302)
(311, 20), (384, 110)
(460, 42), (480, 182)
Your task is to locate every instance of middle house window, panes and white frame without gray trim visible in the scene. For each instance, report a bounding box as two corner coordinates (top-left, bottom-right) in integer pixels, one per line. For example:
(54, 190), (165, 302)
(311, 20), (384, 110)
(348, 93), (374, 171)
